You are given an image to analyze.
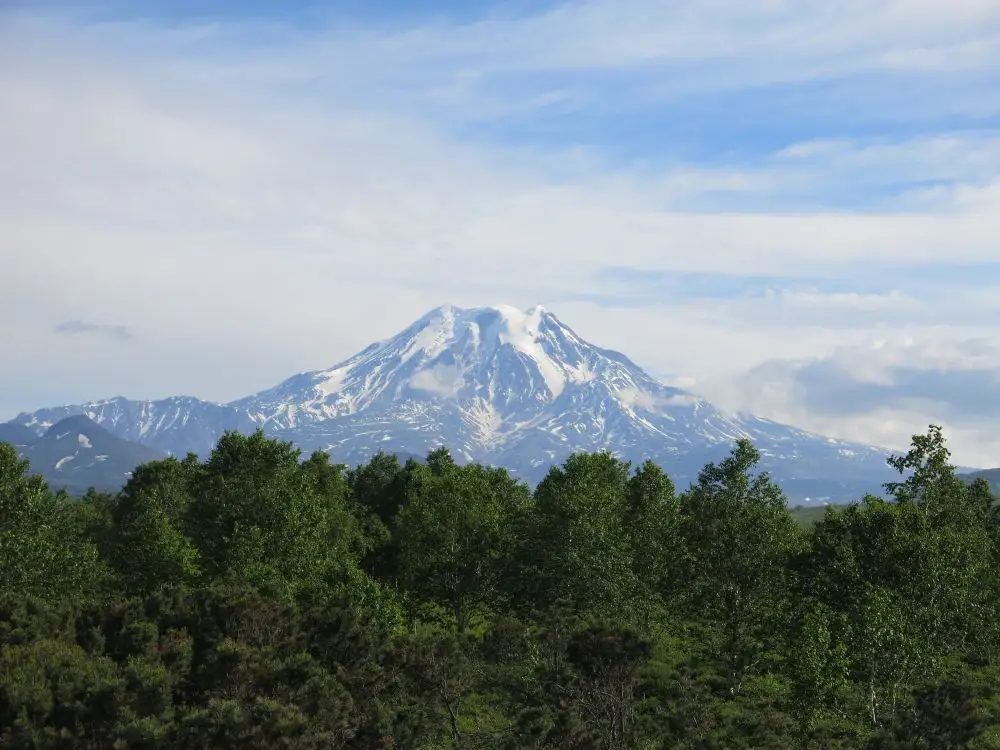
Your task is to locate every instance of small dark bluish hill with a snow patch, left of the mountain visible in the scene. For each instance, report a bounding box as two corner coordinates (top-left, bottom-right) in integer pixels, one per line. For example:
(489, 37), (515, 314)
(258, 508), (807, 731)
(15, 415), (166, 492)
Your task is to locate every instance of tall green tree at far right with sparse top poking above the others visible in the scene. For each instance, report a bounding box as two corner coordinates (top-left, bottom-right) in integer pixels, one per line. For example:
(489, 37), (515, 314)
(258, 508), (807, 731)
(800, 425), (997, 728)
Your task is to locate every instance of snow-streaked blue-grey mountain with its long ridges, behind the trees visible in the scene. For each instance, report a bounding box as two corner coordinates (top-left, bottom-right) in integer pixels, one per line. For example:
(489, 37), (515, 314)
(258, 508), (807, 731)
(5, 306), (889, 499)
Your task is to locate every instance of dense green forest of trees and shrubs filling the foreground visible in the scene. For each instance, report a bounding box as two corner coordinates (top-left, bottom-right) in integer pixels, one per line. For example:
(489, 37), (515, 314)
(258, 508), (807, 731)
(0, 425), (1000, 750)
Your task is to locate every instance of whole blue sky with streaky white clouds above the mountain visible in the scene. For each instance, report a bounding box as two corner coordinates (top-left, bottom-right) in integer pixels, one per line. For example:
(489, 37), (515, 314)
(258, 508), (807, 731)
(0, 0), (1000, 464)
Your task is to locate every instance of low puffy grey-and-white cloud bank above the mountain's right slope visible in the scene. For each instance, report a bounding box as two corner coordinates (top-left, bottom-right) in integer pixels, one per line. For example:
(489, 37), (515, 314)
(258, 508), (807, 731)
(695, 340), (1000, 467)
